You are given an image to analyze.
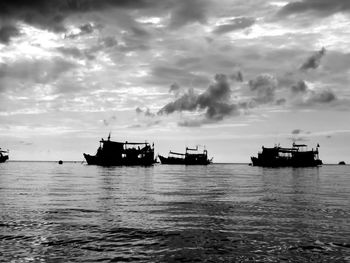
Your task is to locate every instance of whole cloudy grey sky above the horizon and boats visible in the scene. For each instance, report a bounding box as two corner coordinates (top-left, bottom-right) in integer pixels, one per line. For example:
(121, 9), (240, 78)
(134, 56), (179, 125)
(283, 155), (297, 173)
(0, 0), (350, 163)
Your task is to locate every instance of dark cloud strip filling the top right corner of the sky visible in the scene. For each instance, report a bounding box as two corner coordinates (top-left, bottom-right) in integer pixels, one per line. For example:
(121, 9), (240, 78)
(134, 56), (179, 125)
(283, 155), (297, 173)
(278, 0), (350, 17)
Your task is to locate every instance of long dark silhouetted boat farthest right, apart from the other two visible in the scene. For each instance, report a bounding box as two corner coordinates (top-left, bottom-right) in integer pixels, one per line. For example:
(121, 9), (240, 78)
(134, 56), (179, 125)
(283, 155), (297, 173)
(251, 143), (322, 167)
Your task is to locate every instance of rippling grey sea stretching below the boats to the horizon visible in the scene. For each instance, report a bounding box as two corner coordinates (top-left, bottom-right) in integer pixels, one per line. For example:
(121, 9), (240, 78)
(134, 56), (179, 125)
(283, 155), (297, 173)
(0, 164), (350, 262)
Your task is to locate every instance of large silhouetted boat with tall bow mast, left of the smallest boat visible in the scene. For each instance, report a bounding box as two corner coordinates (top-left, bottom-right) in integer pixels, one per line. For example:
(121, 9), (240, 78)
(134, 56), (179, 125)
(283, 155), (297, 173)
(83, 134), (155, 166)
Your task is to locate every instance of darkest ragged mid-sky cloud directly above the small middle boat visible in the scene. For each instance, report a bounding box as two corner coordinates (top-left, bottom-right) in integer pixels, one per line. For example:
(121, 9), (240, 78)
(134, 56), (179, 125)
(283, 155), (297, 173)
(158, 74), (239, 121)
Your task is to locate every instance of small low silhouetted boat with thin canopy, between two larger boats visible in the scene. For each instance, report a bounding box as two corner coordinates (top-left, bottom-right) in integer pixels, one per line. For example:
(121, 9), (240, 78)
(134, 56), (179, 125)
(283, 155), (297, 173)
(158, 146), (213, 165)
